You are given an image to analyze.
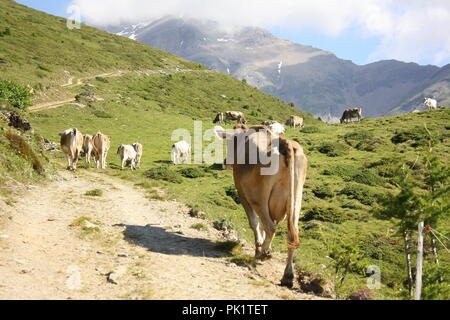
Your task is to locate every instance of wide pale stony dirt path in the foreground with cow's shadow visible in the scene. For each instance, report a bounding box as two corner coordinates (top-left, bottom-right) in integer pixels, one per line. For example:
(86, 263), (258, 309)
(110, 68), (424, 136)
(0, 171), (324, 300)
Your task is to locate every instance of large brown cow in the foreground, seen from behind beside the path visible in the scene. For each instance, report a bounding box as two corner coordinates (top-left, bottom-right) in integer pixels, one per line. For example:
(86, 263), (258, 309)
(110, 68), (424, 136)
(214, 126), (307, 287)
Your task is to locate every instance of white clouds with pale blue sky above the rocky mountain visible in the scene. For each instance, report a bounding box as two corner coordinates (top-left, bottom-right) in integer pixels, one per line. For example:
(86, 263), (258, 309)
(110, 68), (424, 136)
(73, 0), (450, 64)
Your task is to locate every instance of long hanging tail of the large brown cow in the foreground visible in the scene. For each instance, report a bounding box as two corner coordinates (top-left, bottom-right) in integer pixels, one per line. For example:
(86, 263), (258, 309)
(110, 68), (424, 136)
(287, 144), (306, 249)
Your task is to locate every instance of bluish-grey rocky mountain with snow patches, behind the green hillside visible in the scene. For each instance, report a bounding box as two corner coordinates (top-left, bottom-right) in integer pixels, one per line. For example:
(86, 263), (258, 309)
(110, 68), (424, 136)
(107, 17), (450, 118)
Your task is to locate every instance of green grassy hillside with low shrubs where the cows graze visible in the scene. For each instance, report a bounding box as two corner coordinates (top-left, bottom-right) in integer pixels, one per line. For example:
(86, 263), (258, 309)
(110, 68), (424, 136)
(0, 0), (450, 298)
